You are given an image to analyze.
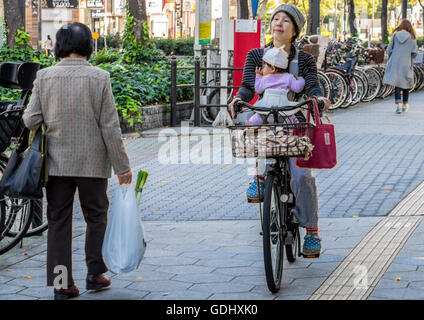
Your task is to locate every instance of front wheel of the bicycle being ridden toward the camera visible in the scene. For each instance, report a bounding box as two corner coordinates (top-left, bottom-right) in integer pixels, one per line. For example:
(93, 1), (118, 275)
(262, 174), (284, 293)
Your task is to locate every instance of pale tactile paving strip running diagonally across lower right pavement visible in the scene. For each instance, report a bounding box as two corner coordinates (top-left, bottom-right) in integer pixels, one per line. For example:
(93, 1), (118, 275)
(309, 183), (424, 300)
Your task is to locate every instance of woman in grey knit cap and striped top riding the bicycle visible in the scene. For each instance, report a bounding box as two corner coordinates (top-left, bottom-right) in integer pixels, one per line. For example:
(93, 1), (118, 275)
(228, 4), (330, 256)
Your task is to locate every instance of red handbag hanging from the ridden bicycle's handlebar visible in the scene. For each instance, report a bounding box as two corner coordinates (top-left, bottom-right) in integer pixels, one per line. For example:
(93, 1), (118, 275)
(295, 101), (337, 169)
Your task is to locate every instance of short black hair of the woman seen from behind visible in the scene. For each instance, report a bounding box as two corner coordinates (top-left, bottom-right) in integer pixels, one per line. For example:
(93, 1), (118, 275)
(54, 22), (93, 59)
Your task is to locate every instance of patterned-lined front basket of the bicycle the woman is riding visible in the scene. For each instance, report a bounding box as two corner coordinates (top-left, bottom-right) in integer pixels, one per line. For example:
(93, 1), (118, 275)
(229, 123), (314, 159)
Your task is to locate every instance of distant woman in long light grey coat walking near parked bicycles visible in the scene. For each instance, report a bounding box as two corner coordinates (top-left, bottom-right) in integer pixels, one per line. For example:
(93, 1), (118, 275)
(383, 19), (418, 114)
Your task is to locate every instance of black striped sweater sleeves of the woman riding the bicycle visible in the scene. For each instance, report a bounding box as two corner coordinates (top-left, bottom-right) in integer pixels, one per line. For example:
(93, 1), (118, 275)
(237, 46), (322, 102)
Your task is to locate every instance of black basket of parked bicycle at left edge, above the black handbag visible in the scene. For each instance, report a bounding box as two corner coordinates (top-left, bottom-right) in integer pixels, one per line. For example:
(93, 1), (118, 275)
(0, 102), (25, 152)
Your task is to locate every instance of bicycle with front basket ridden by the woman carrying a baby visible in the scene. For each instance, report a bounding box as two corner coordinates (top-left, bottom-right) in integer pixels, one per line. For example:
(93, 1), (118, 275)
(229, 99), (322, 293)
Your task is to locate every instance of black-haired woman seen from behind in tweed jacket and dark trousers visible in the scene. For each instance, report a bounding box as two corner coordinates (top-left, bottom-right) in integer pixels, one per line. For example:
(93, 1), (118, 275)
(23, 23), (132, 299)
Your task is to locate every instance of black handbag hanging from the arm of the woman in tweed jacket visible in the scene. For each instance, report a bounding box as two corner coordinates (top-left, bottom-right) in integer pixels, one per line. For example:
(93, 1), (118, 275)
(0, 124), (47, 200)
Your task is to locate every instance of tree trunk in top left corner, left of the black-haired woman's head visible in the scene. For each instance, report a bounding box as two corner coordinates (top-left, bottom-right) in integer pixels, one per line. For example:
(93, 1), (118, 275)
(3, 0), (25, 48)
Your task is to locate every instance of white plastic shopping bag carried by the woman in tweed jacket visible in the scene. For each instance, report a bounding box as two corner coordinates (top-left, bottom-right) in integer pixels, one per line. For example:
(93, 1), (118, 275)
(102, 185), (146, 274)
